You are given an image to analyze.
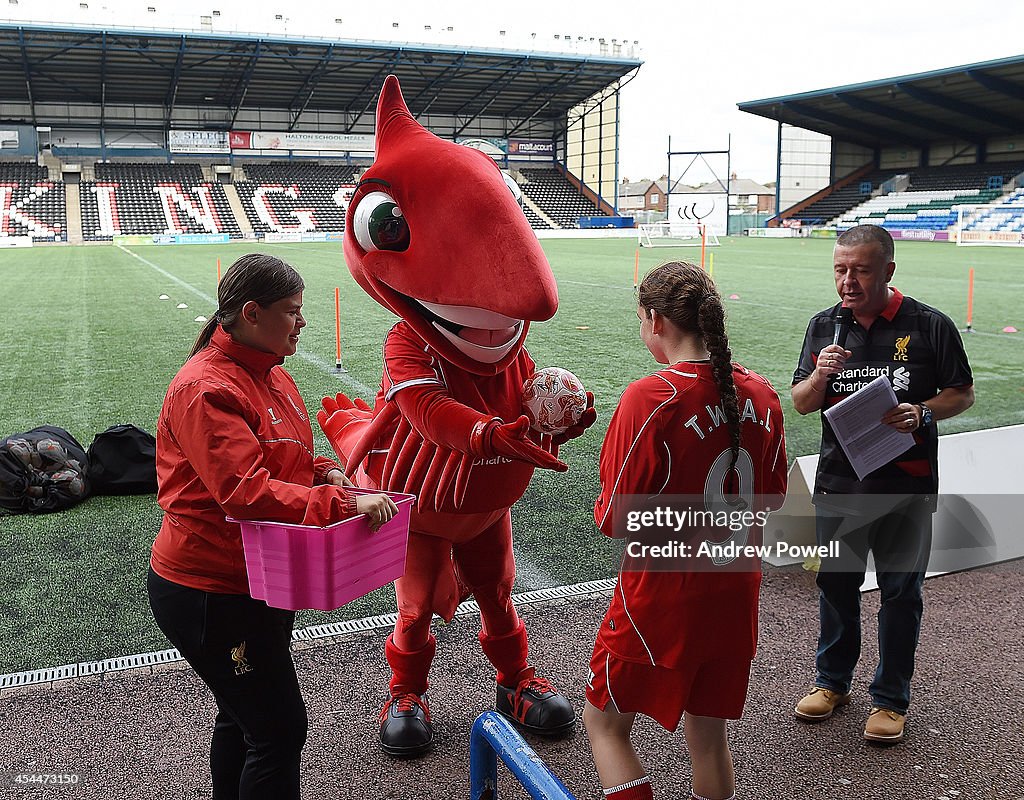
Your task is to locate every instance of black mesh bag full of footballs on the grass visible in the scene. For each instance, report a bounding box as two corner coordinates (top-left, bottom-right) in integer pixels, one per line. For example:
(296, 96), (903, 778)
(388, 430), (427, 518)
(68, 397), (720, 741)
(0, 425), (90, 514)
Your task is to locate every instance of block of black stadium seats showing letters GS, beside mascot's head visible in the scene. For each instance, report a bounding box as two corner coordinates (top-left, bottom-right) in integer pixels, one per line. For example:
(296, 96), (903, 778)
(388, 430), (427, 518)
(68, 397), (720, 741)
(234, 162), (364, 234)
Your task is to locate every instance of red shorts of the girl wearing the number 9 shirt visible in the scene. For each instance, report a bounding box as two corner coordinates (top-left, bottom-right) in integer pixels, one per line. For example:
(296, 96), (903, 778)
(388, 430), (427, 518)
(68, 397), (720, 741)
(587, 639), (751, 731)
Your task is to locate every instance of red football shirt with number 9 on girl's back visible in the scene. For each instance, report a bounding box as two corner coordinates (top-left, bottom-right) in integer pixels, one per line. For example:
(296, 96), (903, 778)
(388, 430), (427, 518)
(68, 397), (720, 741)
(594, 362), (786, 669)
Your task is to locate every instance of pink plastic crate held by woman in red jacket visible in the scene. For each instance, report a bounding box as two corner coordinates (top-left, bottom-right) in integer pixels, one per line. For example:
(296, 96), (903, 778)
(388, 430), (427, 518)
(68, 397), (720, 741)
(228, 489), (416, 612)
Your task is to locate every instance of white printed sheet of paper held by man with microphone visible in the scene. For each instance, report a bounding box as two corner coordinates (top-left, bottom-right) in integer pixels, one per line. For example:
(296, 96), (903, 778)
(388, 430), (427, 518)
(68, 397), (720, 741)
(825, 375), (913, 480)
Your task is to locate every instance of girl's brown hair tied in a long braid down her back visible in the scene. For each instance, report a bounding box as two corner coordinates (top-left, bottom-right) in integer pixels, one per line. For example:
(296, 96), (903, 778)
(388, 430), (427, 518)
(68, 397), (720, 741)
(637, 261), (740, 472)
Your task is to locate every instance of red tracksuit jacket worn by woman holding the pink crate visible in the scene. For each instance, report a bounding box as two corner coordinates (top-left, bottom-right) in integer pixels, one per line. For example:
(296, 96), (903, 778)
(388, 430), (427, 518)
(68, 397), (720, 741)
(151, 327), (355, 594)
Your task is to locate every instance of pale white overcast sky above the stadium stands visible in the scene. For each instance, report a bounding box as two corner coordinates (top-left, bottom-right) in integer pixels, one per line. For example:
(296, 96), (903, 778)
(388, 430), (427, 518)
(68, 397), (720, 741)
(8, 0), (1024, 182)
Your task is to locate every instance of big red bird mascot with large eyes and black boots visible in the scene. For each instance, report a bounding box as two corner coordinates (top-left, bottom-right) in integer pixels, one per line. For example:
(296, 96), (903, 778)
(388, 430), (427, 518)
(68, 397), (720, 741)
(317, 76), (597, 756)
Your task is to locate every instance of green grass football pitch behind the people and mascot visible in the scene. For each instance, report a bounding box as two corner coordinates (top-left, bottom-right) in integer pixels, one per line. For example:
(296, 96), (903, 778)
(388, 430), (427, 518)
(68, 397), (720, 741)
(0, 238), (1024, 673)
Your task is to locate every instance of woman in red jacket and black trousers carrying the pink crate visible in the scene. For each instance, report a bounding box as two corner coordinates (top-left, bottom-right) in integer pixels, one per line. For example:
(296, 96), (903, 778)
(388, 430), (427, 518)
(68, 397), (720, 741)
(148, 254), (397, 800)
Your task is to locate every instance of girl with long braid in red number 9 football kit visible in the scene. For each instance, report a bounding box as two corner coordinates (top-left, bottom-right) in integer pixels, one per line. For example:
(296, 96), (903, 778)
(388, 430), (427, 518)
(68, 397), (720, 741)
(584, 262), (786, 800)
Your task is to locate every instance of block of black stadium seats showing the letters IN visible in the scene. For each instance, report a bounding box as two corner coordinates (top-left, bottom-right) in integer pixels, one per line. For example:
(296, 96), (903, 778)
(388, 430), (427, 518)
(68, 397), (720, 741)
(81, 163), (242, 242)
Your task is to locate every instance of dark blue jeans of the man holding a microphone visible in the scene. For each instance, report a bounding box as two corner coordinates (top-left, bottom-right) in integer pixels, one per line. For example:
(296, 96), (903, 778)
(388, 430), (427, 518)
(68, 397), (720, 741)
(815, 496), (932, 714)
